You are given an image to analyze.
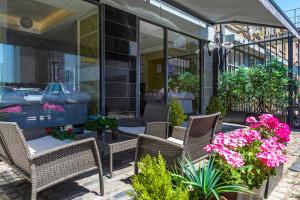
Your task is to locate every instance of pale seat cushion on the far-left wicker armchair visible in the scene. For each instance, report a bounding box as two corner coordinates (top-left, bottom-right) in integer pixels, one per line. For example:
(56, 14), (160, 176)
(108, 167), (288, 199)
(27, 136), (72, 155)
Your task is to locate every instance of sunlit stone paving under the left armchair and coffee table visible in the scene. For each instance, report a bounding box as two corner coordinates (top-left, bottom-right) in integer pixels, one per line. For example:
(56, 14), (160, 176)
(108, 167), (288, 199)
(0, 150), (135, 200)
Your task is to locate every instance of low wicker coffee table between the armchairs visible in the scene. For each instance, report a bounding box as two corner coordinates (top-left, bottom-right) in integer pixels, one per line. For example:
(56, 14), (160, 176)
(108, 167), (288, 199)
(97, 131), (137, 177)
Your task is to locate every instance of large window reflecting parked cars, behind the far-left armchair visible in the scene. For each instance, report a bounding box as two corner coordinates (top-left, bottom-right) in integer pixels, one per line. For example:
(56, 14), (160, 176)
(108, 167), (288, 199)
(0, 0), (99, 128)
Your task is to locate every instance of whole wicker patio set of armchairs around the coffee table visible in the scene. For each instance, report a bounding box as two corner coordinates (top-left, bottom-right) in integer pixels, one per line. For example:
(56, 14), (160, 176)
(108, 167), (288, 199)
(0, 105), (220, 200)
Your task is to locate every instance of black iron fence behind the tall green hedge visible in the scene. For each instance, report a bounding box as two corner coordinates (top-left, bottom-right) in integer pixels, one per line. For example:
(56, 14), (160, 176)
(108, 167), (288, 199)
(224, 33), (300, 127)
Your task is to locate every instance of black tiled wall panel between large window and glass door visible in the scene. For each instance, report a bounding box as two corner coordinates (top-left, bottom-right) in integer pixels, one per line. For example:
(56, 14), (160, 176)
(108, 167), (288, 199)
(105, 6), (137, 117)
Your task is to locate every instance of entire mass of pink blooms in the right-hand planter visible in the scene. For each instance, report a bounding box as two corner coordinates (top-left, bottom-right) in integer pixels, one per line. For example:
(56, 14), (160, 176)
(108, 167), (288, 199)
(204, 114), (291, 168)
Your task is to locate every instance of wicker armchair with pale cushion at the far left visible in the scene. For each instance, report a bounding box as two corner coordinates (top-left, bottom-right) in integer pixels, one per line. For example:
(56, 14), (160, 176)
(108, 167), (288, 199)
(0, 122), (104, 200)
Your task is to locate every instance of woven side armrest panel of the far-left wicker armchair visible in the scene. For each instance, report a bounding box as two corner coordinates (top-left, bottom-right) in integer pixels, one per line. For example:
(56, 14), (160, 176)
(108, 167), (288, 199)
(29, 138), (102, 189)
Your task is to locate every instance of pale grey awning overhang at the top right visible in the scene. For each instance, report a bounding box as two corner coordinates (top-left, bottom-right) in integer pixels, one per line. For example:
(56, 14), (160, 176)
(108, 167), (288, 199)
(163, 0), (300, 39)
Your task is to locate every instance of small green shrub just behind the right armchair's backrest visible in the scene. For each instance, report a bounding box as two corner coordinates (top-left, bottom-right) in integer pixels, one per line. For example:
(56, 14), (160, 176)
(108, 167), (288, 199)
(205, 97), (227, 132)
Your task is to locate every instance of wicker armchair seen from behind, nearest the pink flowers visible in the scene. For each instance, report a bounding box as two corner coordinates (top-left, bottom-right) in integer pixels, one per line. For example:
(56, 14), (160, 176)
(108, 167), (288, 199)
(135, 113), (220, 173)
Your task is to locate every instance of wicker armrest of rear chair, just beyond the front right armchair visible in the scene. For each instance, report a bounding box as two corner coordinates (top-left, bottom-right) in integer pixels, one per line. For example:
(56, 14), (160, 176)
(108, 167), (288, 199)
(145, 122), (170, 139)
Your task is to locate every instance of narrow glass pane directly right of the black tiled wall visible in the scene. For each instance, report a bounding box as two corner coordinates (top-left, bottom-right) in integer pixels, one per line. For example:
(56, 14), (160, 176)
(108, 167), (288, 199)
(140, 21), (165, 114)
